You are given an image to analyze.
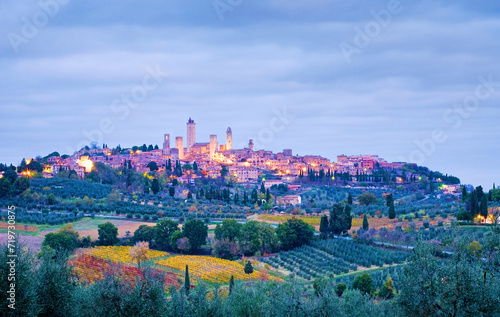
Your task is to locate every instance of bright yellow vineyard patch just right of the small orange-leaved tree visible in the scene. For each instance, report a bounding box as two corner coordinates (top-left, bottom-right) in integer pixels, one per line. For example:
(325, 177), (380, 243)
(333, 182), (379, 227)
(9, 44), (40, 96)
(155, 255), (260, 283)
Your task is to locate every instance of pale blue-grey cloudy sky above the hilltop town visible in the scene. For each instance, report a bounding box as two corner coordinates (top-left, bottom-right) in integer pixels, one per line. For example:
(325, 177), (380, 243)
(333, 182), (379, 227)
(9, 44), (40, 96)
(0, 0), (500, 188)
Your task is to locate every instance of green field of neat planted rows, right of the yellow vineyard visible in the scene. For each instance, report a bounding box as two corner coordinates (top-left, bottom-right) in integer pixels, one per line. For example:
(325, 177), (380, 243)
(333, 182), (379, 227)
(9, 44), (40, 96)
(260, 239), (409, 280)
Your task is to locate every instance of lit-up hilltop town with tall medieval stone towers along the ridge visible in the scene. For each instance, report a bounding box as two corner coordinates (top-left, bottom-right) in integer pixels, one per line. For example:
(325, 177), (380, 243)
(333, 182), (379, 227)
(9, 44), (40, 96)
(13, 118), (460, 193)
